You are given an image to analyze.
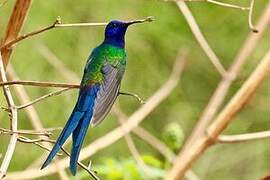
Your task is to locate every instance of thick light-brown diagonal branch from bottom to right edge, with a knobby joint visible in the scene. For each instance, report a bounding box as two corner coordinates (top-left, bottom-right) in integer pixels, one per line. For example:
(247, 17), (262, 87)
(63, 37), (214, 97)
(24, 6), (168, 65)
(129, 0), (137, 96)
(167, 50), (270, 179)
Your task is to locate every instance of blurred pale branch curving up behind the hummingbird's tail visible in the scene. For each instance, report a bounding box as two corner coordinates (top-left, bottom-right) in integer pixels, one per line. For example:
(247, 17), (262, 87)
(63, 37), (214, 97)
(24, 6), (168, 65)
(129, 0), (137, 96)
(8, 49), (188, 179)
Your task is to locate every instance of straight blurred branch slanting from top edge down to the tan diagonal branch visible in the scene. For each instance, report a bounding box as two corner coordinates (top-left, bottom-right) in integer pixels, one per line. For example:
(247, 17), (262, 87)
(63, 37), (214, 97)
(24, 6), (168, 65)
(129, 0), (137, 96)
(175, 1), (227, 77)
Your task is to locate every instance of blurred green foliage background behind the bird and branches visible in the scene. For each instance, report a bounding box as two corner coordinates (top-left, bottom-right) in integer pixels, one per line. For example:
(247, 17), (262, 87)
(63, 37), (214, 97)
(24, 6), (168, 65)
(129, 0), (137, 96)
(0, 0), (270, 180)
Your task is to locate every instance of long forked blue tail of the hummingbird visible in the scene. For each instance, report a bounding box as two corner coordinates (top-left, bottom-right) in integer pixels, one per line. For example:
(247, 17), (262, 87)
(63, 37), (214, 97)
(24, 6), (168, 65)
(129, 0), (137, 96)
(41, 85), (99, 175)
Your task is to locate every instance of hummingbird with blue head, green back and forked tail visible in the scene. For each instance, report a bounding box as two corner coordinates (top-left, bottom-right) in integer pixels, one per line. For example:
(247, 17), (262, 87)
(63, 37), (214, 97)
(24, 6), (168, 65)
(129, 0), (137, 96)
(41, 17), (153, 176)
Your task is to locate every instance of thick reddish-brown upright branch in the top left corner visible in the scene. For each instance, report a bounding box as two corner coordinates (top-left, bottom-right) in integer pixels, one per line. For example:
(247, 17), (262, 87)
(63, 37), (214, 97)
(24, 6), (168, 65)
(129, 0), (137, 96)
(1, 0), (32, 67)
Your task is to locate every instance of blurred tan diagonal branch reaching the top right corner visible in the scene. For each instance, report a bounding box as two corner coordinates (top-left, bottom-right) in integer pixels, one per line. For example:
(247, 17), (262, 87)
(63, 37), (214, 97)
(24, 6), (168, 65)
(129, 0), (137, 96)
(181, 3), (270, 153)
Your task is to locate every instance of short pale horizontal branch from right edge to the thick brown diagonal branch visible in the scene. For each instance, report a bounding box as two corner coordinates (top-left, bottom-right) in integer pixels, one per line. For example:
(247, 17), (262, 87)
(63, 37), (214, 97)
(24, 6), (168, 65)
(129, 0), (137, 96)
(216, 131), (270, 143)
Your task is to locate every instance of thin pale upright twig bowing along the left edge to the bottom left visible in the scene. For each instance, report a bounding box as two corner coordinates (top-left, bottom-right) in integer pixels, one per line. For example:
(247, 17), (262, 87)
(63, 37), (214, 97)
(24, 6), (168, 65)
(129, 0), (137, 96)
(0, 52), (18, 179)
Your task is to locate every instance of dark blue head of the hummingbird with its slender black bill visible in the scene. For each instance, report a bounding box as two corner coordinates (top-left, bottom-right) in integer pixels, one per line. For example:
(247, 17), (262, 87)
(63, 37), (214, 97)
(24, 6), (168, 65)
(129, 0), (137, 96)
(104, 20), (141, 48)
